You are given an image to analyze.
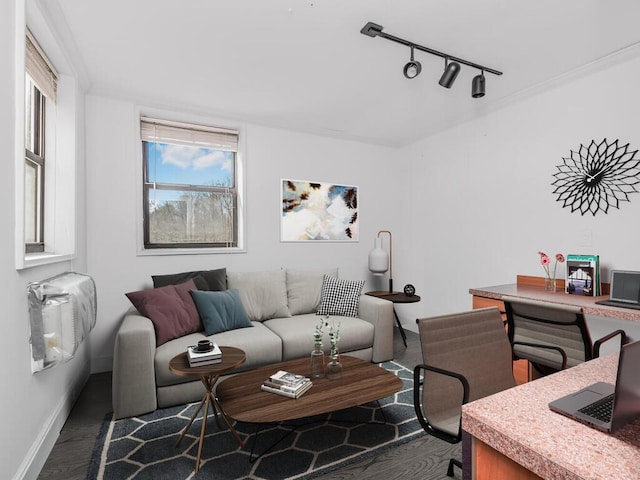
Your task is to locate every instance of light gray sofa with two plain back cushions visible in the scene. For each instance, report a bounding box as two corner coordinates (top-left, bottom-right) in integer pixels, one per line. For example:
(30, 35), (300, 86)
(112, 269), (393, 418)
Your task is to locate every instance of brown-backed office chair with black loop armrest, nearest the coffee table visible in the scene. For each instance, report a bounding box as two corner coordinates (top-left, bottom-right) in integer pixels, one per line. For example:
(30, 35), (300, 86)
(413, 307), (515, 477)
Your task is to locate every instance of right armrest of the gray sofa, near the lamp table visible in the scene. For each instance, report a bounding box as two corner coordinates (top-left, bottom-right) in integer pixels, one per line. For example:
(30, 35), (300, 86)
(358, 295), (393, 363)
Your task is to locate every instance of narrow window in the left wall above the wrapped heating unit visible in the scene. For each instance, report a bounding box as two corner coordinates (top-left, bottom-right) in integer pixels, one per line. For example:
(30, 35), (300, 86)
(24, 34), (56, 253)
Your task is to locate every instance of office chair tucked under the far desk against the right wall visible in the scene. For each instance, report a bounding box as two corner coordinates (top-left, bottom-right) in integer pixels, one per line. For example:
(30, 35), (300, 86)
(502, 297), (627, 375)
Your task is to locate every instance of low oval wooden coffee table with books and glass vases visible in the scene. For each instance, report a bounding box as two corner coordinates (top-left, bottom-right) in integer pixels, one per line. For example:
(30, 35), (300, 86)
(216, 355), (402, 456)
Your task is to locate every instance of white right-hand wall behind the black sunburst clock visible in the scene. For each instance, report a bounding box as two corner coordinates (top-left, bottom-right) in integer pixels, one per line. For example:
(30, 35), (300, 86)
(402, 53), (640, 327)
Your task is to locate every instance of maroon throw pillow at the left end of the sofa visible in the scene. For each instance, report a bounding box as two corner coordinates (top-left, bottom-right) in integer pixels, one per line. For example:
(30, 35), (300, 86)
(126, 280), (202, 346)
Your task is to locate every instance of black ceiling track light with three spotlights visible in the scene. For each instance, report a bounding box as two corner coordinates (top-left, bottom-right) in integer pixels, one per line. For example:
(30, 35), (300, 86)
(360, 22), (502, 98)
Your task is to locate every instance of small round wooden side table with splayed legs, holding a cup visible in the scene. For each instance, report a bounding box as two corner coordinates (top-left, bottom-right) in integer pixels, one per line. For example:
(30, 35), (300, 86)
(169, 347), (246, 472)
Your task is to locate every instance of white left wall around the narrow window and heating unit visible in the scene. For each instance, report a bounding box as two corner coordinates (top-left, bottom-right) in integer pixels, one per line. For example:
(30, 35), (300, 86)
(0, 0), (90, 479)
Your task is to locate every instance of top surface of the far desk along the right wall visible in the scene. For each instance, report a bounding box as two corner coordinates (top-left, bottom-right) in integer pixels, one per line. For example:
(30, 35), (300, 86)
(469, 283), (640, 322)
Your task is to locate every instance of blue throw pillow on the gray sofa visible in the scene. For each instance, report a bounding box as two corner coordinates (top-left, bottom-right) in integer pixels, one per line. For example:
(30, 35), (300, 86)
(191, 289), (251, 335)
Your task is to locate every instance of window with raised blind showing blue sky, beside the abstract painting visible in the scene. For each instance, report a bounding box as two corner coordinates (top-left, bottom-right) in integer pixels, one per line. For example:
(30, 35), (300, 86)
(140, 117), (239, 249)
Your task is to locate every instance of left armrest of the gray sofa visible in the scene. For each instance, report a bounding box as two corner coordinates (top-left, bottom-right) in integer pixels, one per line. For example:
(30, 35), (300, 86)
(112, 309), (158, 419)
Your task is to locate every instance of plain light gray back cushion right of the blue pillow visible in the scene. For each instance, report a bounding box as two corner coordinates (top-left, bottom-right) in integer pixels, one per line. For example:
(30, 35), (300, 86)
(227, 270), (291, 322)
